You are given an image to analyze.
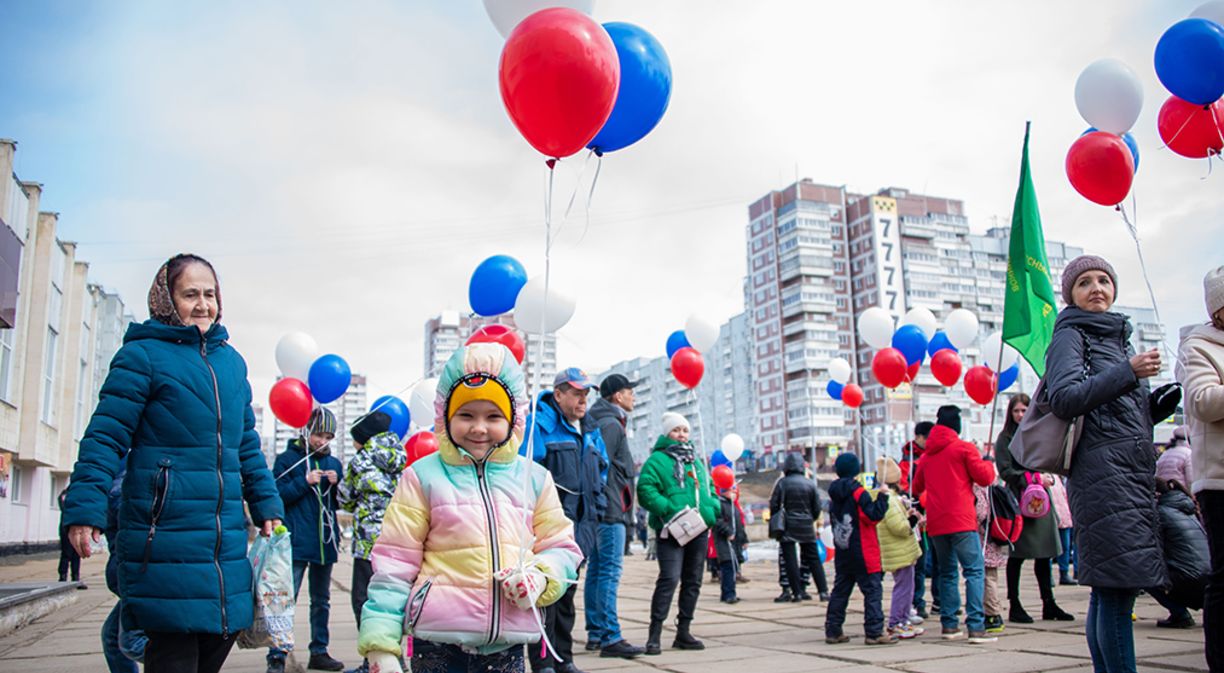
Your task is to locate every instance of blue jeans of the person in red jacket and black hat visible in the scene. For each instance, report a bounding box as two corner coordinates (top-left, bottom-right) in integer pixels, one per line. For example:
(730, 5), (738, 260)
(930, 531), (987, 633)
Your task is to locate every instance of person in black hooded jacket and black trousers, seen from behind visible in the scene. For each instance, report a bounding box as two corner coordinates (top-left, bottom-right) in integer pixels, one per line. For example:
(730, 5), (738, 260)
(769, 452), (829, 602)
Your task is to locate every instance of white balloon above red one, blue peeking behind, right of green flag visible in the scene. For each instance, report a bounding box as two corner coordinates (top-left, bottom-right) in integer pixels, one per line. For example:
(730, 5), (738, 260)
(1066, 59), (1143, 206)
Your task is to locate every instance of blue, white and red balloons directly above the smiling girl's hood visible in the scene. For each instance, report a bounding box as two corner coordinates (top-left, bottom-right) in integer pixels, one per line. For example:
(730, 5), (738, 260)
(468, 255), (578, 335)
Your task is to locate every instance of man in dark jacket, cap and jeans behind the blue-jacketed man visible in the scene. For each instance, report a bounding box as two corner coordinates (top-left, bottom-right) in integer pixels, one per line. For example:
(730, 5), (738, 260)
(583, 374), (645, 658)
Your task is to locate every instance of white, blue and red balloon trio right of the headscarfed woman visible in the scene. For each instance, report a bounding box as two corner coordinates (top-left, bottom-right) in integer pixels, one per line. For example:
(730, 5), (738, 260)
(268, 332), (353, 427)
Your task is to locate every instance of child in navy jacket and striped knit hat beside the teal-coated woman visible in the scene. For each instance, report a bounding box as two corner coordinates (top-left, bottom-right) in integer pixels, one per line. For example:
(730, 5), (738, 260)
(268, 406), (344, 673)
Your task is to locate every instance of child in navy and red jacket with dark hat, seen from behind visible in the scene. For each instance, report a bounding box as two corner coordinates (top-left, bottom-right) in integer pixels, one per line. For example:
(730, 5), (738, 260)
(825, 453), (897, 645)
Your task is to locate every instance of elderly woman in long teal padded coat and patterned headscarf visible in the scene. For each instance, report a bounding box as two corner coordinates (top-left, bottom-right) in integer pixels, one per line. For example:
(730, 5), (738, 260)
(62, 255), (284, 673)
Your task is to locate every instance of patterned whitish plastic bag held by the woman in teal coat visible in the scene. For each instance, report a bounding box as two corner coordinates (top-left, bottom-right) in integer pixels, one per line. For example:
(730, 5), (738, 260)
(237, 526), (294, 652)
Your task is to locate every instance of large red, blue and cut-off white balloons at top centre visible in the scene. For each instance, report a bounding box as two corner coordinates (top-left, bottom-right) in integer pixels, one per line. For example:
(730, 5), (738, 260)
(485, 0), (672, 159)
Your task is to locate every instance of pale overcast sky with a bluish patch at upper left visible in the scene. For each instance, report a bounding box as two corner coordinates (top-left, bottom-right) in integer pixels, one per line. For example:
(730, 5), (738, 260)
(0, 0), (1224, 420)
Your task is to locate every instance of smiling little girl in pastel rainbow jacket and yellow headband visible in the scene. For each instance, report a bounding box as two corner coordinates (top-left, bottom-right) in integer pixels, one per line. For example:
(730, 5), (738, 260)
(357, 344), (583, 673)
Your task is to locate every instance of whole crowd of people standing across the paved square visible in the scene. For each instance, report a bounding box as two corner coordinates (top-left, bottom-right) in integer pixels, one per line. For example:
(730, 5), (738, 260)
(60, 255), (1224, 673)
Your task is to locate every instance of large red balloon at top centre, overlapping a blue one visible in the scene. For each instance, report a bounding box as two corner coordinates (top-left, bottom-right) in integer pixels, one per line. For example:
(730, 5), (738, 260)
(498, 7), (621, 158)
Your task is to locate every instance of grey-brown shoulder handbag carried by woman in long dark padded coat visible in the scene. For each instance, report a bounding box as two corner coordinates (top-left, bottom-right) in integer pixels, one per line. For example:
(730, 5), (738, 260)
(1009, 332), (1092, 476)
